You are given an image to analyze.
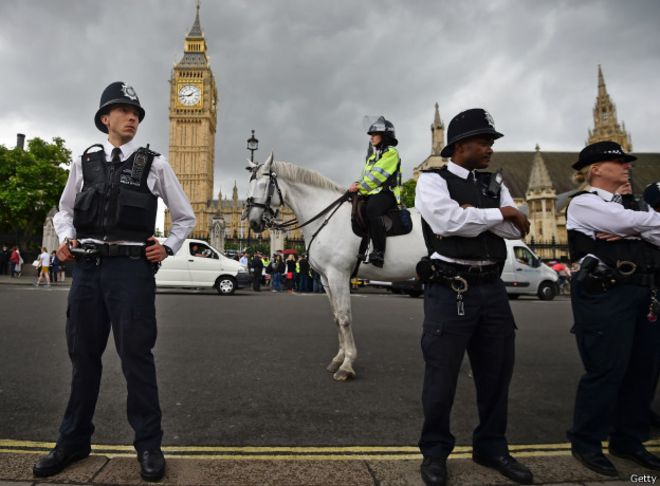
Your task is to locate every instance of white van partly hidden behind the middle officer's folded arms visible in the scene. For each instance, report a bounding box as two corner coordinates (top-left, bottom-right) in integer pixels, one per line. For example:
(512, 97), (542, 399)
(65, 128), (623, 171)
(502, 240), (559, 300)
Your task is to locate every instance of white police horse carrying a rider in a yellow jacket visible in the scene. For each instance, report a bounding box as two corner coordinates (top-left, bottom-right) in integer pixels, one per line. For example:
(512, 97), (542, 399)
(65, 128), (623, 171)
(243, 154), (427, 381)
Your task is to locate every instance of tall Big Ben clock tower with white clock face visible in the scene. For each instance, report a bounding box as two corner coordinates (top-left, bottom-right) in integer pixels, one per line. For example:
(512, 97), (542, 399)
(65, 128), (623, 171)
(165, 2), (218, 239)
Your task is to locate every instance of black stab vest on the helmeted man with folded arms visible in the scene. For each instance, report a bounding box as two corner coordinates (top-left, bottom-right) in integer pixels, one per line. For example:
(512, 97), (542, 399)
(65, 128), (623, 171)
(422, 166), (506, 263)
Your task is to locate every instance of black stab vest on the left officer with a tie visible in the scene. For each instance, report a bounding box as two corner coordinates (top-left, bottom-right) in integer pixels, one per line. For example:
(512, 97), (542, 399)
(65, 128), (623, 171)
(73, 145), (158, 242)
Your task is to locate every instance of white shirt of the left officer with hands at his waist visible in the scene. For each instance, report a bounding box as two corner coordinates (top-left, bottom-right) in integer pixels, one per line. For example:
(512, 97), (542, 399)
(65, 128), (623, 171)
(53, 141), (195, 253)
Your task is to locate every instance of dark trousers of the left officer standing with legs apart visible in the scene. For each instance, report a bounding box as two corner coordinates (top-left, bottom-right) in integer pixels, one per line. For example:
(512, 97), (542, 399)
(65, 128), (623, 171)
(57, 257), (163, 452)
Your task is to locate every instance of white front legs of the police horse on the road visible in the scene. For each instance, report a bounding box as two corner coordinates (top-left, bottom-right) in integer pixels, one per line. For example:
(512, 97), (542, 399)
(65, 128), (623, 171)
(328, 274), (357, 381)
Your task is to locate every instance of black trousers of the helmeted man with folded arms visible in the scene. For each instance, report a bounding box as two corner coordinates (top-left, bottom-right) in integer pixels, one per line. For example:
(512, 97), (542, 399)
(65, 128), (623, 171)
(419, 279), (516, 458)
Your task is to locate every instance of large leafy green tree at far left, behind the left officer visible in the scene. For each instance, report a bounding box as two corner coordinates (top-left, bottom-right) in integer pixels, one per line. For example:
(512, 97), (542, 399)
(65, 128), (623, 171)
(0, 137), (71, 246)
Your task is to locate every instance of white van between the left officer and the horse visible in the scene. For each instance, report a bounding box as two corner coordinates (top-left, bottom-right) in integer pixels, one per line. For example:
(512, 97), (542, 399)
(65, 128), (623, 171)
(156, 238), (252, 295)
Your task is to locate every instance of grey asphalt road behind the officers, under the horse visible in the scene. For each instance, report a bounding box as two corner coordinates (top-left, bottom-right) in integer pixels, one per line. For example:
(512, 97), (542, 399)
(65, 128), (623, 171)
(0, 285), (660, 446)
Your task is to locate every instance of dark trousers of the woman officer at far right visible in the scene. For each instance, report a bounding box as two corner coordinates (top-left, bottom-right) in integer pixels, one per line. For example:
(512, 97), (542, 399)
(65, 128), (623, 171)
(568, 281), (660, 453)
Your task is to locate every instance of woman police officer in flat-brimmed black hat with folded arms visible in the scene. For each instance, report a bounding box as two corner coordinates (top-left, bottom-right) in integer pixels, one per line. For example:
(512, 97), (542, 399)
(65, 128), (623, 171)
(566, 141), (660, 476)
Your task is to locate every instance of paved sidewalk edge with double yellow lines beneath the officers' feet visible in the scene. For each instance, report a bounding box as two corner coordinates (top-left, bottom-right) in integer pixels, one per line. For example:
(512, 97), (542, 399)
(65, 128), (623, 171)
(0, 440), (660, 486)
